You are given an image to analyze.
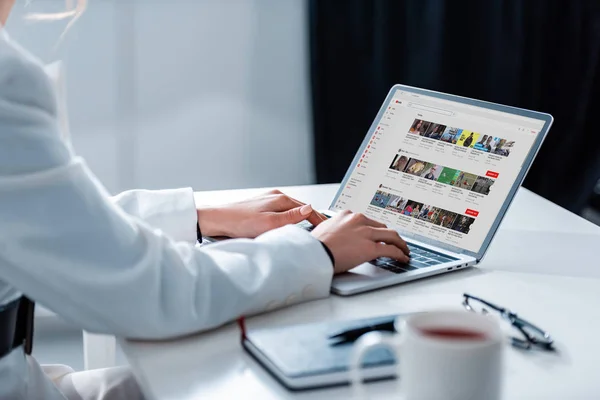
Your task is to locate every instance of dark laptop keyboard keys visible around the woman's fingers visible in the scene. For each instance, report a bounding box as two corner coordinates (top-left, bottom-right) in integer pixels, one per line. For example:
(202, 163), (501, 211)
(298, 221), (457, 274)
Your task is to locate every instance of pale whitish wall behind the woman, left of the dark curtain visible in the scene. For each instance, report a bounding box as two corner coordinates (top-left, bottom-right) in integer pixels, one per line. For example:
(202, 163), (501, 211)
(7, 0), (314, 192)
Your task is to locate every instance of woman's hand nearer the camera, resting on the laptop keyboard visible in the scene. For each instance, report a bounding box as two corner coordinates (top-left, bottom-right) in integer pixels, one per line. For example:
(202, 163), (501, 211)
(312, 211), (410, 274)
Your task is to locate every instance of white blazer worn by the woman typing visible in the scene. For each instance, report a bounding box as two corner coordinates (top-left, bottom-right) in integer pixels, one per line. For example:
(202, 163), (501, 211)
(0, 28), (333, 399)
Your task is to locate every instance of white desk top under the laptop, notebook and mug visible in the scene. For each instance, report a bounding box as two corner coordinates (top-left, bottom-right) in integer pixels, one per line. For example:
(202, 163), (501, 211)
(121, 185), (600, 400)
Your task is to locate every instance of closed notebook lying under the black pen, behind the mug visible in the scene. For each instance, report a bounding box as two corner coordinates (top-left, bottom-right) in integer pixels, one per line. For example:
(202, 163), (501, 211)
(243, 316), (397, 390)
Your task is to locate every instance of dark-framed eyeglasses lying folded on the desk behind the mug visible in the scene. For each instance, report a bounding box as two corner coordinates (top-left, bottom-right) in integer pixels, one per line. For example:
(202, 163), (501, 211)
(463, 293), (554, 351)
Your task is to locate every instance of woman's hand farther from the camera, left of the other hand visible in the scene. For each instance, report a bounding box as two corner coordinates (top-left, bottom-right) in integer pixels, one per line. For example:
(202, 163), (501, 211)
(198, 190), (327, 238)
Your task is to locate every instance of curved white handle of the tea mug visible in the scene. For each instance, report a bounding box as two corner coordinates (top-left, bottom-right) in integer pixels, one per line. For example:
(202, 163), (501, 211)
(349, 332), (400, 399)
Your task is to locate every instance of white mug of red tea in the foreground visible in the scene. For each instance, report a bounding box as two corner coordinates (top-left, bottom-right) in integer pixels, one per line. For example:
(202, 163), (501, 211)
(350, 311), (504, 400)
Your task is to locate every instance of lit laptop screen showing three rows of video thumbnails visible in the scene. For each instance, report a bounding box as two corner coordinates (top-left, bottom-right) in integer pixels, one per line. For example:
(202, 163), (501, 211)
(332, 89), (545, 252)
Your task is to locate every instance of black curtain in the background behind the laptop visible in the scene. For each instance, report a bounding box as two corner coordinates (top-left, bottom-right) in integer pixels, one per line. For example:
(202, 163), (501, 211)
(309, 0), (600, 212)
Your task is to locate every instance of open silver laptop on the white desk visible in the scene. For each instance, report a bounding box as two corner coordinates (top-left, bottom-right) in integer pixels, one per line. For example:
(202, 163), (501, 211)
(301, 85), (553, 296)
